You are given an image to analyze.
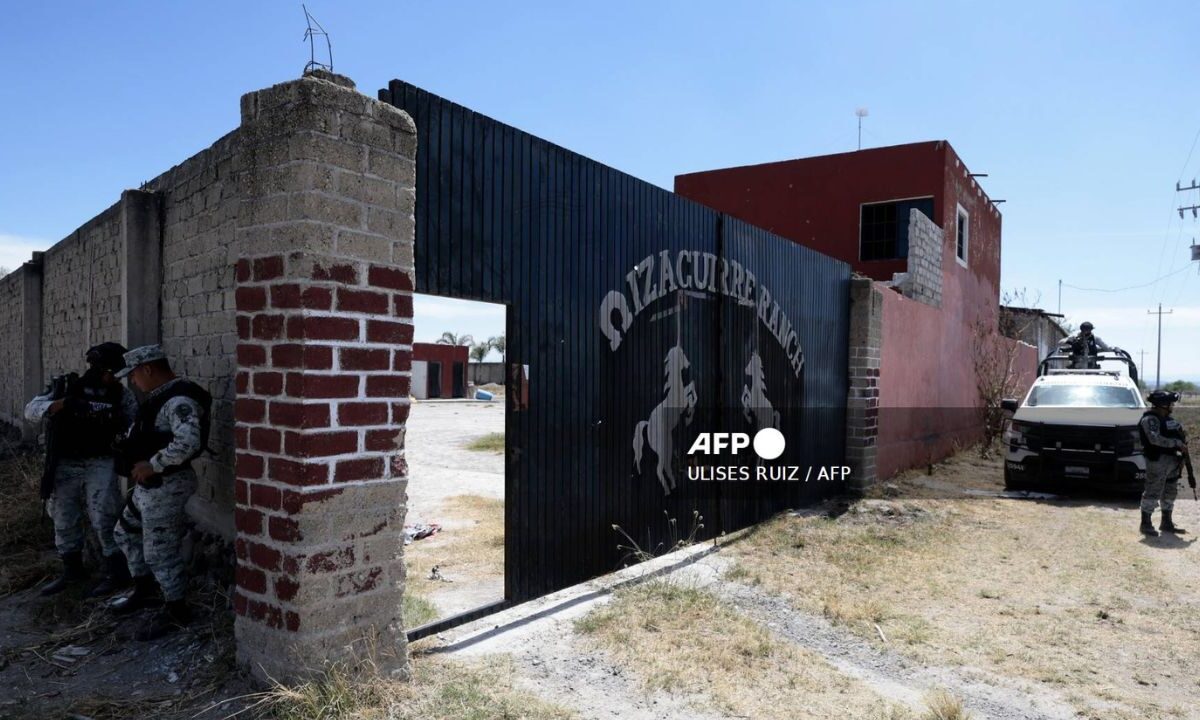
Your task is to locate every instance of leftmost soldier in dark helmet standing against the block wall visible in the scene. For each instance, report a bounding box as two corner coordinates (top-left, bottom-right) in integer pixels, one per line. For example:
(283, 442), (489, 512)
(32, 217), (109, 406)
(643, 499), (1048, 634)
(25, 342), (138, 596)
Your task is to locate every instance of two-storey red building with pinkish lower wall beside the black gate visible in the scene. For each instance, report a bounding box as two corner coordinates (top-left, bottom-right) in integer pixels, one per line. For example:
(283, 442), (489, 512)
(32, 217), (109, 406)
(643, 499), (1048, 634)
(676, 140), (1037, 478)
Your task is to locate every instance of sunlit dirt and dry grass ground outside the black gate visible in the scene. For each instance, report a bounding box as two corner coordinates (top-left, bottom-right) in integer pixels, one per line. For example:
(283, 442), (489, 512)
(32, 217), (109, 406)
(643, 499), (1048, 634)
(415, 408), (1200, 720)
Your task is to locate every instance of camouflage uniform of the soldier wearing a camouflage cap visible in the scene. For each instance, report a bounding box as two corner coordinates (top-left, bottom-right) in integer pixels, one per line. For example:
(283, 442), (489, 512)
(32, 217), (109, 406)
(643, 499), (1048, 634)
(116, 378), (203, 602)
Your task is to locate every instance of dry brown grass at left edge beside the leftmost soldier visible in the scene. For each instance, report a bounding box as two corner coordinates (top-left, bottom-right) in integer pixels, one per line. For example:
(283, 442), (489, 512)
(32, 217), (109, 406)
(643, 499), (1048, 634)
(0, 440), (54, 598)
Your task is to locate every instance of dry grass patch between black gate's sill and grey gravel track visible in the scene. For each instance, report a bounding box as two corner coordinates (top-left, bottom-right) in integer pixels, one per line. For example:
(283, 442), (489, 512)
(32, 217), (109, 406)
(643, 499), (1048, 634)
(576, 581), (908, 719)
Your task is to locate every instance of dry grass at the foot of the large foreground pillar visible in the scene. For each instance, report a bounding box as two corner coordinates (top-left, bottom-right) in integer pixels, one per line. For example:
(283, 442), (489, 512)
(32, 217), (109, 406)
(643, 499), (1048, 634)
(246, 658), (574, 720)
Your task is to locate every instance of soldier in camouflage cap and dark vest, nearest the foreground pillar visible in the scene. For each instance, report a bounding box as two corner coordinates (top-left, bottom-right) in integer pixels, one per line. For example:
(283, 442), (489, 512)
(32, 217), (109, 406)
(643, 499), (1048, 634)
(112, 346), (212, 640)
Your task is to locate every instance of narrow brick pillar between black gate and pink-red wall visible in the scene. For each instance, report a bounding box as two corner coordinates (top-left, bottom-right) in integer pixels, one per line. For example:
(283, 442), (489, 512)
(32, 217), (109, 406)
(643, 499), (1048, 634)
(846, 277), (883, 493)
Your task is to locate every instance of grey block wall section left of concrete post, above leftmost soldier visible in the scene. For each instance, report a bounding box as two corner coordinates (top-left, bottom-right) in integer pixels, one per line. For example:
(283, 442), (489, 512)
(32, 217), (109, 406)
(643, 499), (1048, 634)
(40, 203), (122, 376)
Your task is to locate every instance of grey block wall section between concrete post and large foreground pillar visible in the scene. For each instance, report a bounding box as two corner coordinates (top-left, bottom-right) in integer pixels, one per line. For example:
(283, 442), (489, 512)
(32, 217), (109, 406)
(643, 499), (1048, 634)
(146, 133), (241, 536)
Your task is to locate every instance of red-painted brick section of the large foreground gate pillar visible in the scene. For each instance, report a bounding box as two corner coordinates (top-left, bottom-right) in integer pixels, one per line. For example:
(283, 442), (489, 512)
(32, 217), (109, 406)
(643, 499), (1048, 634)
(234, 253), (413, 634)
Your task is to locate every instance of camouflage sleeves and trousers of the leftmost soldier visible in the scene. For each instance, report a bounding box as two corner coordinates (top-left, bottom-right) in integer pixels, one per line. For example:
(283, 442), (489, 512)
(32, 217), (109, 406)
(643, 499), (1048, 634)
(25, 388), (138, 557)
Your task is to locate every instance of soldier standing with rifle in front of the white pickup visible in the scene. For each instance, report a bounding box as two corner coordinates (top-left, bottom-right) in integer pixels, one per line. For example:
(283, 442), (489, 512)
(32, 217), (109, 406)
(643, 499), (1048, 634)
(1138, 390), (1188, 536)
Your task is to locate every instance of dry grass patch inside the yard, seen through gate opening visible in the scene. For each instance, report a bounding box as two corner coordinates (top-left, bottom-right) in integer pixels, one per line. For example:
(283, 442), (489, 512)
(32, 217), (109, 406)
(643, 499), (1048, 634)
(404, 496), (504, 595)
